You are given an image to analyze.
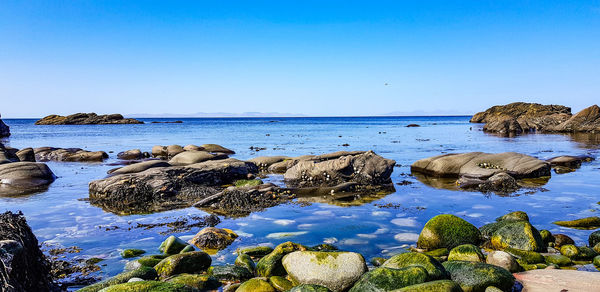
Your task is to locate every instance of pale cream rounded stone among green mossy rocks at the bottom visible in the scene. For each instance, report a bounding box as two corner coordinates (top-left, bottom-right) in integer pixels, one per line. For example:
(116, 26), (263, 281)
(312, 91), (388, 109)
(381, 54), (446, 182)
(282, 251), (367, 292)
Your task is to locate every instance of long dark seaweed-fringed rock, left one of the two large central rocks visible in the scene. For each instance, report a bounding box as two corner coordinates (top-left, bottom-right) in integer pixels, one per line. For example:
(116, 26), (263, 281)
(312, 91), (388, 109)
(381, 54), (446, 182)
(89, 159), (257, 213)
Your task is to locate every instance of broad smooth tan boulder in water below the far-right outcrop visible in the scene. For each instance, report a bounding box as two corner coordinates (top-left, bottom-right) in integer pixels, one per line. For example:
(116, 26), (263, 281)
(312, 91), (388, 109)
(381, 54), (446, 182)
(411, 152), (550, 179)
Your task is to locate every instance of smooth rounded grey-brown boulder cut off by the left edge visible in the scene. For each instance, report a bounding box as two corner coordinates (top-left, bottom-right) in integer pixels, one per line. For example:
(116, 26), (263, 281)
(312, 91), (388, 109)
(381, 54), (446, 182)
(0, 162), (55, 196)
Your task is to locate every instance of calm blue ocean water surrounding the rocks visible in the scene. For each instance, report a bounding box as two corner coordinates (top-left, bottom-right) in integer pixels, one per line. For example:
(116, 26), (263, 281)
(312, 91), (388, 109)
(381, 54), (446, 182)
(0, 117), (600, 286)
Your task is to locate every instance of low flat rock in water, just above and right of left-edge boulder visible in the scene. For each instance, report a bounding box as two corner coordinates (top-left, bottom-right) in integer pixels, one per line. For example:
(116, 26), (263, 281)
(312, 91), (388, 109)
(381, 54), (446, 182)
(33, 147), (108, 162)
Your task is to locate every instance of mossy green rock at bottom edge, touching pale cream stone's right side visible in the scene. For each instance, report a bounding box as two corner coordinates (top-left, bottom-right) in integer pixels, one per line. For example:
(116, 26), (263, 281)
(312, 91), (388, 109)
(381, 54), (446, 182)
(349, 266), (429, 292)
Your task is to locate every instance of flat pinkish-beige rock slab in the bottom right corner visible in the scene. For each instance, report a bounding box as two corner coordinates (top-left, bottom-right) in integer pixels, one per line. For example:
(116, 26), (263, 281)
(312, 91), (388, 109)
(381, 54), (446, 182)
(513, 270), (600, 292)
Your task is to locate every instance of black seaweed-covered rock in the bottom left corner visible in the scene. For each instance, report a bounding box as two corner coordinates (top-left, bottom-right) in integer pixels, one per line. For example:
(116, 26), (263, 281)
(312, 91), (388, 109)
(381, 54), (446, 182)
(0, 212), (58, 292)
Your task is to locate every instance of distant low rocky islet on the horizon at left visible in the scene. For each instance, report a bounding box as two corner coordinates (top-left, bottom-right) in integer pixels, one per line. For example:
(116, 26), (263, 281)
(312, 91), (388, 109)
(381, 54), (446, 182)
(35, 113), (144, 125)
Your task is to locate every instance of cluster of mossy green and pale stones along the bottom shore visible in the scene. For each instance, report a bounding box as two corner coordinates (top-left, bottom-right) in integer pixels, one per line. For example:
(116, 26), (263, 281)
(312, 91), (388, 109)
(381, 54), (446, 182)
(80, 211), (600, 292)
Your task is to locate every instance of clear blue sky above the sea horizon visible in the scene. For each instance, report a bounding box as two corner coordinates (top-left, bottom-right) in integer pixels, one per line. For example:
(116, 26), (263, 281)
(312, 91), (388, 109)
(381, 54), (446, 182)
(0, 0), (600, 118)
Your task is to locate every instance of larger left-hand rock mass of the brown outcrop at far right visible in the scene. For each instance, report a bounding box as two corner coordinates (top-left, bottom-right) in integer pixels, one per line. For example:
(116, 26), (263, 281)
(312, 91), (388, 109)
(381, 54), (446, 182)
(471, 102), (571, 134)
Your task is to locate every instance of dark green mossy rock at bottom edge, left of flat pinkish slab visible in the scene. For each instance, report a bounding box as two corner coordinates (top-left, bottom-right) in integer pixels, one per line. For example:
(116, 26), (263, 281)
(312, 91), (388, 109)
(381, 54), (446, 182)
(443, 261), (515, 292)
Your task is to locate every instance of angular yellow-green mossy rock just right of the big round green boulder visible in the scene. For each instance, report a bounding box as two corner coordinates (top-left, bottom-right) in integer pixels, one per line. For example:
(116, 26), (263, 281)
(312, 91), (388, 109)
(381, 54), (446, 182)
(482, 220), (546, 252)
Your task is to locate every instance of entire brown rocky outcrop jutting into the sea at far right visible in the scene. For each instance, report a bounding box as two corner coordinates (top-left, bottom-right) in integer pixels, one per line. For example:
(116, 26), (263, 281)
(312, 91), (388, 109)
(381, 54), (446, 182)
(471, 102), (600, 135)
